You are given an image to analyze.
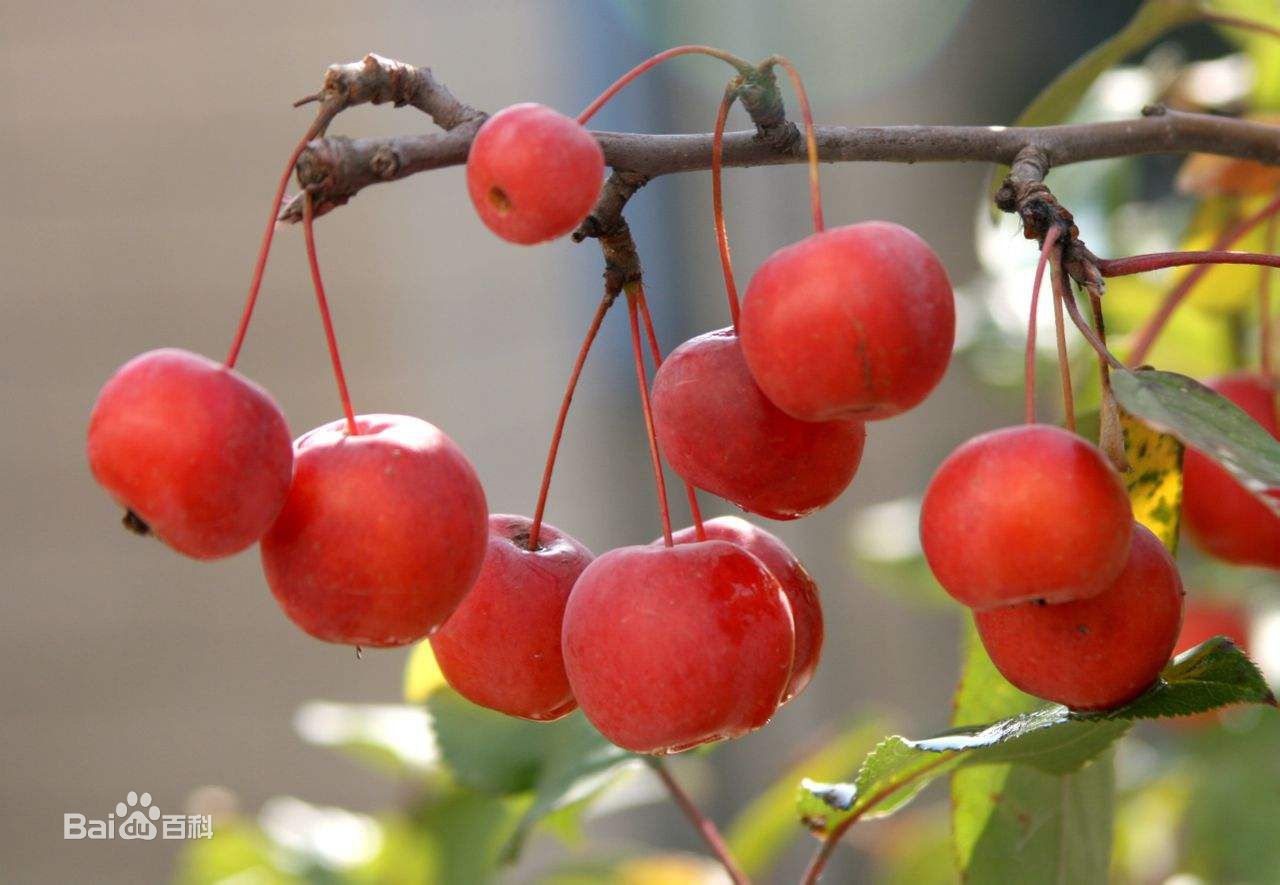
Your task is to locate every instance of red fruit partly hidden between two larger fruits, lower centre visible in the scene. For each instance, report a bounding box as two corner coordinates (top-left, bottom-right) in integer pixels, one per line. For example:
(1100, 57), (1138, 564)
(431, 514), (591, 721)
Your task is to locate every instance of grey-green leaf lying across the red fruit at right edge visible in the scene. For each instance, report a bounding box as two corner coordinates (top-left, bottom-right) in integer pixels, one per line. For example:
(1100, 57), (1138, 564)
(1111, 369), (1280, 514)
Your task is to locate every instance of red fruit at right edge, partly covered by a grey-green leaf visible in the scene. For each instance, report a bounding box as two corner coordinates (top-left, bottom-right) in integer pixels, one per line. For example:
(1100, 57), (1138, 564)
(1183, 373), (1280, 569)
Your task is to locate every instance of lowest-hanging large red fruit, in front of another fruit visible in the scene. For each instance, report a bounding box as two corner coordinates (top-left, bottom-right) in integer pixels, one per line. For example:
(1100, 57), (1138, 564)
(563, 540), (795, 754)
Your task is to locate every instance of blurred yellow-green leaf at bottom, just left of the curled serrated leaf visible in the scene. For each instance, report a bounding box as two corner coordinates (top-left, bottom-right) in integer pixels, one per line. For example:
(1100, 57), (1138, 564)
(726, 721), (884, 876)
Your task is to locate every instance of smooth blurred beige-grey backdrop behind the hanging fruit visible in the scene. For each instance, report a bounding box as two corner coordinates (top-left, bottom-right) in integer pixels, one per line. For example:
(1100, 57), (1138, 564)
(10, 0), (1280, 882)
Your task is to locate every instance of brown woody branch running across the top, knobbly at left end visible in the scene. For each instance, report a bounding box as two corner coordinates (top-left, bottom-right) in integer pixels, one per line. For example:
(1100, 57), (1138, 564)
(280, 55), (1280, 235)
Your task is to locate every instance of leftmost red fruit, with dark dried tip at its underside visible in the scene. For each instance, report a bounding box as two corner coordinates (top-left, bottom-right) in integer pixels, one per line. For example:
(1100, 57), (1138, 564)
(87, 348), (293, 560)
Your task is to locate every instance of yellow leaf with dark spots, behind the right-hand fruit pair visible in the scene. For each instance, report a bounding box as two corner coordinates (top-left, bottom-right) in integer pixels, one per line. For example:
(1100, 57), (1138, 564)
(1120, 410), (1183, 553)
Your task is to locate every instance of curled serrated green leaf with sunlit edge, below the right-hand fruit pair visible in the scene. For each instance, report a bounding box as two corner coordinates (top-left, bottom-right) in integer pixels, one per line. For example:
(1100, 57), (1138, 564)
(797, 638), (1275, 835)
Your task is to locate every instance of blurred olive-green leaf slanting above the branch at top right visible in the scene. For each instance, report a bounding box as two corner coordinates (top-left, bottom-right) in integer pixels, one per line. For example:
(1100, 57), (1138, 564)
(987, 0), (1208, 216)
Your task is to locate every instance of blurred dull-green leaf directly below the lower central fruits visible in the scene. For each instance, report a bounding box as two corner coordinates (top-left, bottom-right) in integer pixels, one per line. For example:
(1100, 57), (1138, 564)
(426, 689), (637, 861)
